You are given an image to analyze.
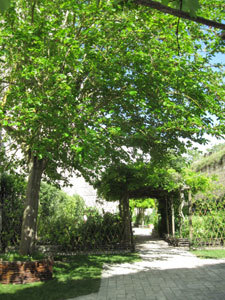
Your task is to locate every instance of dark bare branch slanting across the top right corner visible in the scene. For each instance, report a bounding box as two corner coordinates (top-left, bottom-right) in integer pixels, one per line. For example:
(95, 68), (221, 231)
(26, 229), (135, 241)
(134, 0), (225, 30)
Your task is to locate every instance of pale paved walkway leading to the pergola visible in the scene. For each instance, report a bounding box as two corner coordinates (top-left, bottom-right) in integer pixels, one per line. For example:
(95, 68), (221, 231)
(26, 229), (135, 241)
(69, 230), (225, 300)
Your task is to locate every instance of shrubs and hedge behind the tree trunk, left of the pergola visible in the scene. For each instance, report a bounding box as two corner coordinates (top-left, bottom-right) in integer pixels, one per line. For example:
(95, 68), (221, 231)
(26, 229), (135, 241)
(0, 178), (126, 253)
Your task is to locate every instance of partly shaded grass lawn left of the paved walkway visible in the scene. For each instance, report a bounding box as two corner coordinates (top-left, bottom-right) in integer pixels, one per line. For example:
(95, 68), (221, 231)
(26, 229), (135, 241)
(0, 254), (140, 300)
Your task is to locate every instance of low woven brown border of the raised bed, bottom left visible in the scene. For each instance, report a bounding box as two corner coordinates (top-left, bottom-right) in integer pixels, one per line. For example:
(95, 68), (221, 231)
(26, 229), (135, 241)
(0, 259), (53, 284)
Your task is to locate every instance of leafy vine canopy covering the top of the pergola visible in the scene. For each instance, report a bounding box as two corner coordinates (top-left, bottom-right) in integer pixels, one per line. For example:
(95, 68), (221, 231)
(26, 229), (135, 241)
(94, 156), (216, 207)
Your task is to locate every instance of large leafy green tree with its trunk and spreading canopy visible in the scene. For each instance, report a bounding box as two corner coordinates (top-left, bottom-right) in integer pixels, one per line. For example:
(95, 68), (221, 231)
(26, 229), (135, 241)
(0, 0), (224, 254)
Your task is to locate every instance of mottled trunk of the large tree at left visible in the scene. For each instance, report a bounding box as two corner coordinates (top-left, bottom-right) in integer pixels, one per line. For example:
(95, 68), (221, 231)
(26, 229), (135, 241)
(19, 157), (45, 255)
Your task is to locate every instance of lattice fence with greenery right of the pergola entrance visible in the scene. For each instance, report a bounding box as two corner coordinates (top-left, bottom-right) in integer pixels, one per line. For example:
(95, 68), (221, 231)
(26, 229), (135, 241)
(167, 193), (225, 248)
